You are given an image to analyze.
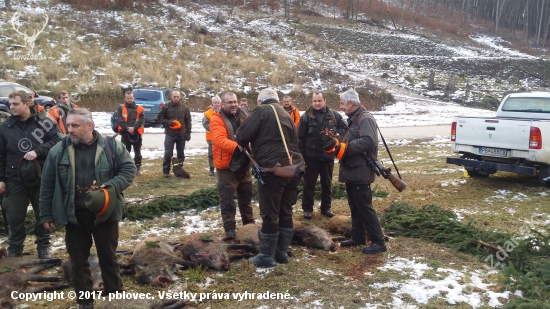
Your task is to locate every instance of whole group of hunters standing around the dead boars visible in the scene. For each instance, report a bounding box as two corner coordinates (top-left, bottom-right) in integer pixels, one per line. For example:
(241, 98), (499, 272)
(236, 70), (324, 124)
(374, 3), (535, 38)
(0, 88), (386, 308)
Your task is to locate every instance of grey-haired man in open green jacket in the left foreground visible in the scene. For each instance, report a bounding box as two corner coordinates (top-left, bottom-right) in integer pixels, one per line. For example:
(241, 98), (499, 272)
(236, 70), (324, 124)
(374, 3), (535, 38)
(40, 108), (136, 308)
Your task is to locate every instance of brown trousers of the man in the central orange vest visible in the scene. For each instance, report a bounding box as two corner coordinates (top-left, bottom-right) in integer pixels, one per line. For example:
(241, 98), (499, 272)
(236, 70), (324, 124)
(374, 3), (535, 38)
(218, 169), (254, 232)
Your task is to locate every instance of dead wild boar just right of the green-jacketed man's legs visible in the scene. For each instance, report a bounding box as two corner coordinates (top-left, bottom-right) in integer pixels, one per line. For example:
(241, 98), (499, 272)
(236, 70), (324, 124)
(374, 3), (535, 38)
(130, 237), (194, 287)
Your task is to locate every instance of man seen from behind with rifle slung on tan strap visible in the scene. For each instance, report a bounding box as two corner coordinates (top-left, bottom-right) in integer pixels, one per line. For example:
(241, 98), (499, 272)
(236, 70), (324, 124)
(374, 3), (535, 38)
(237, 88), (304, 267)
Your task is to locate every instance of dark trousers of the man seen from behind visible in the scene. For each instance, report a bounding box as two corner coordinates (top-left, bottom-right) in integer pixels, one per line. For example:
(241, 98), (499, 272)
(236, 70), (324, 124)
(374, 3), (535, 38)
(258, 175), (301, 234)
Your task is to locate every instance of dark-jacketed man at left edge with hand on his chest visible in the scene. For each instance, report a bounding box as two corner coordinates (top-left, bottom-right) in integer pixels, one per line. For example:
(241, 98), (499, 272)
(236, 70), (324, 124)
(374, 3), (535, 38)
(0, 91), (59, 259)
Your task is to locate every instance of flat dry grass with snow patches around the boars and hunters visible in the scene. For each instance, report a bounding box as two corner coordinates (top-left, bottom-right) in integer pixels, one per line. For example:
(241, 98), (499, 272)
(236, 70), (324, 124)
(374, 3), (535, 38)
(3, 140), (550, 308)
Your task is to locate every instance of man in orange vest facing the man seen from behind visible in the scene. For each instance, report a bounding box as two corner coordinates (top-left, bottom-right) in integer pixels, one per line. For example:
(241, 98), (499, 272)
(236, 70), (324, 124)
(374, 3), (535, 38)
(210, 91), (254, 239)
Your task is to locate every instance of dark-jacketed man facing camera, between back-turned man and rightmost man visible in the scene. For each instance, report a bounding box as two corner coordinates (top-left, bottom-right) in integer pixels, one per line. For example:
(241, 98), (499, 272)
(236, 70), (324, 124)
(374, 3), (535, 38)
(298, 92), (346, 219)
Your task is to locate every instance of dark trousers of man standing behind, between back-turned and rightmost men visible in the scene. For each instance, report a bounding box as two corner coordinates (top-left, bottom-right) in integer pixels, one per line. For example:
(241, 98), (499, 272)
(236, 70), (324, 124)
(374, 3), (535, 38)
(302, 159), (334, 212)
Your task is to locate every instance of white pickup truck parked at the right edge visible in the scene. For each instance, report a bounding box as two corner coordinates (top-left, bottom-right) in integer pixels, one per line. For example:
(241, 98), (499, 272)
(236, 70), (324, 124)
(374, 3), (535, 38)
(447, 92), (550, 184)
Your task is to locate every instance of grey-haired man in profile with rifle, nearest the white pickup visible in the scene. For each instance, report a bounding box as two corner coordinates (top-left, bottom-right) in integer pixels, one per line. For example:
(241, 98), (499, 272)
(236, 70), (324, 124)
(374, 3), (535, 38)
(324, 89), (387, 254)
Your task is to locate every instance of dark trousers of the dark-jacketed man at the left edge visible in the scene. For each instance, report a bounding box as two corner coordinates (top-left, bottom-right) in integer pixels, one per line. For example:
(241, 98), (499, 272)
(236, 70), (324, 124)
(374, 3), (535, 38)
(2, 181), (50, 255)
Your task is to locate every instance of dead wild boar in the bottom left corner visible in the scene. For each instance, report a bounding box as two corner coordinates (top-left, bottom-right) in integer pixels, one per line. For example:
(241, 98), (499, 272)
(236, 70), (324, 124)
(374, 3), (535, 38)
(0, 257), (68, 308)
